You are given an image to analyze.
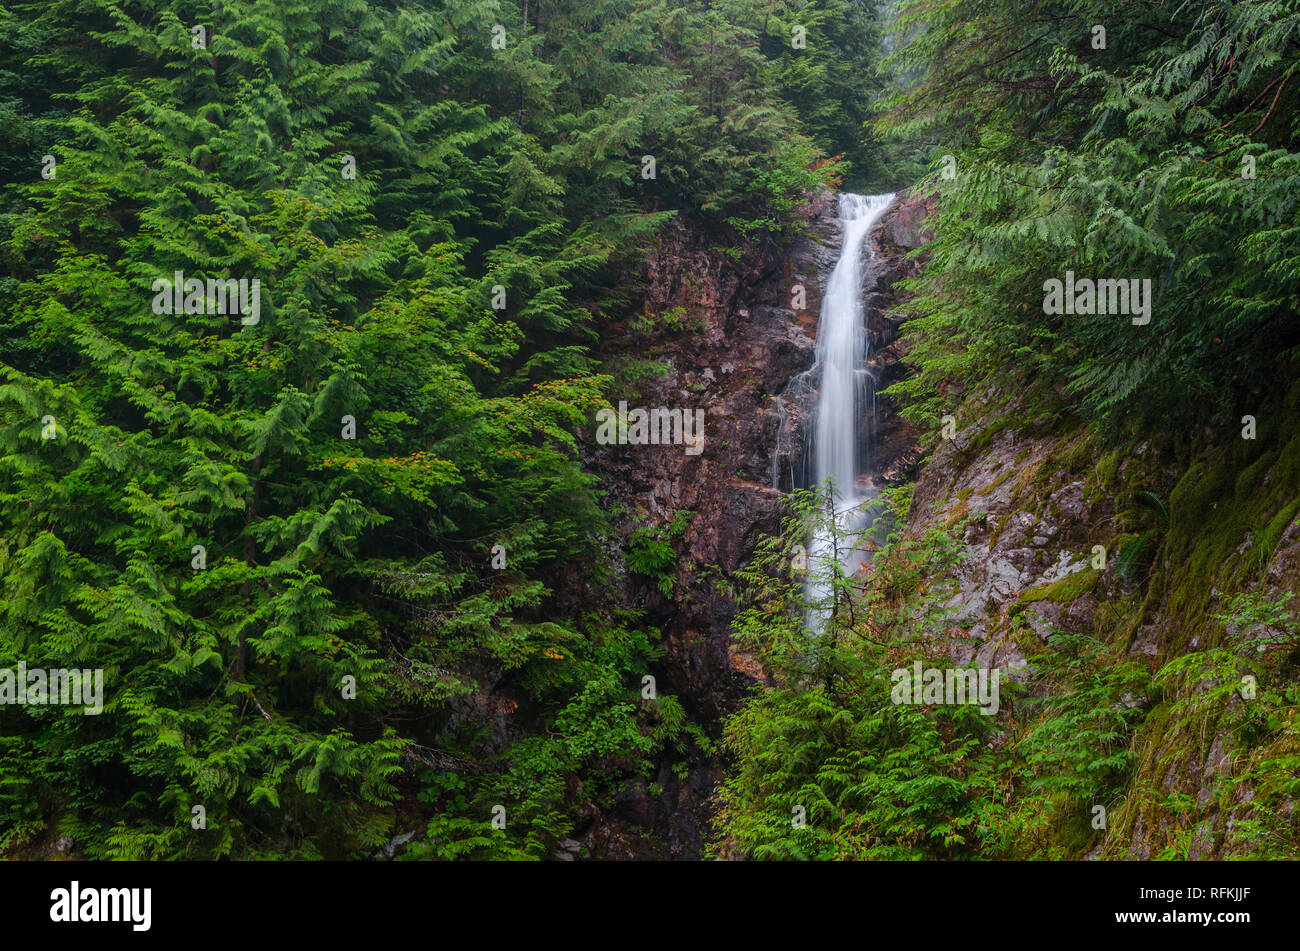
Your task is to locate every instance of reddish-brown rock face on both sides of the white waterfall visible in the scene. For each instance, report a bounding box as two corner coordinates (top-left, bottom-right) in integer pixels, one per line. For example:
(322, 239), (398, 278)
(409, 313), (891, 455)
(569, 194), (924, 857)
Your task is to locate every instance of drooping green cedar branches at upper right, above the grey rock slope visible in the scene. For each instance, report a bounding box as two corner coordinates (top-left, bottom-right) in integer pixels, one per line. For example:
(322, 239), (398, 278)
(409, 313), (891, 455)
(881, 0), (1300, 434)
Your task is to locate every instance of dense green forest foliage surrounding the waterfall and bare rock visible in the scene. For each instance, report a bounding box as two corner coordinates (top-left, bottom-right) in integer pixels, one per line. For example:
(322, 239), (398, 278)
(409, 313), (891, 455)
(0, 0), (1300, 859)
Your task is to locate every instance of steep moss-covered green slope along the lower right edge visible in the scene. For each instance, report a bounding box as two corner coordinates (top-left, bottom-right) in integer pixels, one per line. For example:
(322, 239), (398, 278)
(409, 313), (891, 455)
(1105, 376), (1300, 857)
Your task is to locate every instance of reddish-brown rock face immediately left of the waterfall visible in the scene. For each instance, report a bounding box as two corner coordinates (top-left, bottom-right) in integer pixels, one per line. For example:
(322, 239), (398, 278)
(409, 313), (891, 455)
(590, 196), (835, 722)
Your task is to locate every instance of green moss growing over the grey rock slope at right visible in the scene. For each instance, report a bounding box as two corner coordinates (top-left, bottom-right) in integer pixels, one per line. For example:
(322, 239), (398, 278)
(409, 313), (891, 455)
(904, 358), (1300, 857)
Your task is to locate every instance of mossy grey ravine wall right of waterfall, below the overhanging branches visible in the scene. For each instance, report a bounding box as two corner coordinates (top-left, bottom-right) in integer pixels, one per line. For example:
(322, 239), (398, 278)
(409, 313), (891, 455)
(907, 219), (1300, 859)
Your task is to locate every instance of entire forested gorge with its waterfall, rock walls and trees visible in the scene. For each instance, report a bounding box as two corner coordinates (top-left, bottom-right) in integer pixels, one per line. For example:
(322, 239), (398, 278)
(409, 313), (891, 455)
(0, 0), (1300, 867)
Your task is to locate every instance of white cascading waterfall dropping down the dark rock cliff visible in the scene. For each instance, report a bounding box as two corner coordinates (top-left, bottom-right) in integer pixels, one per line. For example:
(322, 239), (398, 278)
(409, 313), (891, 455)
(807, 194), (894, 628)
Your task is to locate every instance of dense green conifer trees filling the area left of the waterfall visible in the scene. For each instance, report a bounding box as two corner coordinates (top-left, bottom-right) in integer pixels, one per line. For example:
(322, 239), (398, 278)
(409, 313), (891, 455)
(0, 0), (863, 859)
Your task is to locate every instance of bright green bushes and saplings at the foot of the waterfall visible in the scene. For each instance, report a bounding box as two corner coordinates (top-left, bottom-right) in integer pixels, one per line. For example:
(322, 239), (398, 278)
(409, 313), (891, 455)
(715, 492), (992, 859)
